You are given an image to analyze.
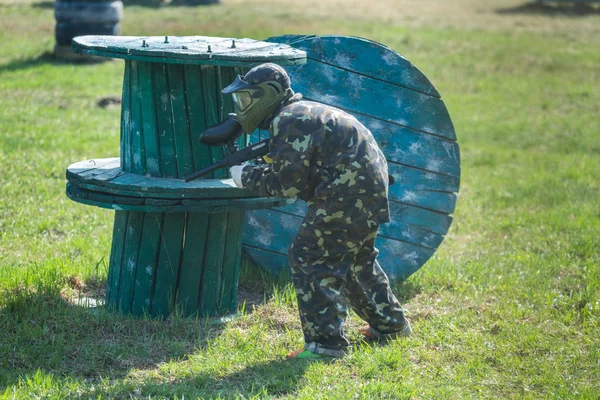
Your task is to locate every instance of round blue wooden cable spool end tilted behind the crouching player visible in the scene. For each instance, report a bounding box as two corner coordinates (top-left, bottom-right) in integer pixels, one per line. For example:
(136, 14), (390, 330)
(243, 36), (460, 280)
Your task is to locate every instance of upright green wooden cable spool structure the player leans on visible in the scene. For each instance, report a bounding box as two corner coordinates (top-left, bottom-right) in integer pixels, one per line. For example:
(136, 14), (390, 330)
(67, 36), (306, 317)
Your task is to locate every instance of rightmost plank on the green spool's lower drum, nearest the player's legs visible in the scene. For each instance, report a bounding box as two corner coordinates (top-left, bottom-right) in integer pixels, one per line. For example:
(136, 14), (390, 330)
(218, 211), (244, 314)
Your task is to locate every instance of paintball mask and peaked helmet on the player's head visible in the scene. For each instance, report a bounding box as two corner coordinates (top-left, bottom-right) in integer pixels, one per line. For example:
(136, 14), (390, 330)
(223, 63), (294, 133)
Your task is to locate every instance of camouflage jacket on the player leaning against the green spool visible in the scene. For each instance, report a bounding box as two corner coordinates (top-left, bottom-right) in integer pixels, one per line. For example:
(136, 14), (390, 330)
(242, 95), (389, 224)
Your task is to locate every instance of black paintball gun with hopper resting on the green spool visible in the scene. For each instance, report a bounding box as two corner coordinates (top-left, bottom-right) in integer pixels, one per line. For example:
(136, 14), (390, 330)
(184, 114), (269, 182)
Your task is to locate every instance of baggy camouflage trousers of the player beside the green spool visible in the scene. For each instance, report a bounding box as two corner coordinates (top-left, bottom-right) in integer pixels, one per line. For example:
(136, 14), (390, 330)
(289, 198), (407, 356)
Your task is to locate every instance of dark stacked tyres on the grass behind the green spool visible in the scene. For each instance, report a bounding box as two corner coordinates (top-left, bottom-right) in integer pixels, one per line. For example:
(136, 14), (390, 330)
(54, 0), (123, 60)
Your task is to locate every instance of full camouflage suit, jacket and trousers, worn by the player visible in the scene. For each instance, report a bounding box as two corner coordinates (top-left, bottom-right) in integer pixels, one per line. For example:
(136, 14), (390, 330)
(242, 94), (407, 356)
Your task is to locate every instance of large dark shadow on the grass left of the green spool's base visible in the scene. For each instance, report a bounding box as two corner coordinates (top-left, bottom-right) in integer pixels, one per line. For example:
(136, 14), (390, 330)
(0, 288), (224, 387)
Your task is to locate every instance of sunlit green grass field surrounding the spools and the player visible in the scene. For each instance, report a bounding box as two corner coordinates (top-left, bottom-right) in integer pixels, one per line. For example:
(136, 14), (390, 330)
(0, 0), (600, 399)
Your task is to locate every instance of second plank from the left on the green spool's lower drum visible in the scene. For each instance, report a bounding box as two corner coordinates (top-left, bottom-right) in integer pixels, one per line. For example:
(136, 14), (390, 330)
(118, 212), (144, 314)
